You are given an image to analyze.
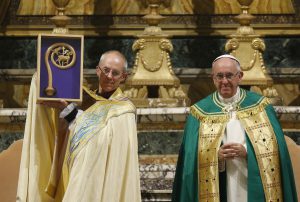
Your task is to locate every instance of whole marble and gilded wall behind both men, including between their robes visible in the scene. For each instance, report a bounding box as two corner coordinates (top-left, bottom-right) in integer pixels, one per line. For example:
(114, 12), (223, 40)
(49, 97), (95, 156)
(0, 0), (300, 201)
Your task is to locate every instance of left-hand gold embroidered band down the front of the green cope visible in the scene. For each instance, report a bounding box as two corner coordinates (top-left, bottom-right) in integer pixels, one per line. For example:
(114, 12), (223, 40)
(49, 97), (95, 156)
(191, 106), (228, 202)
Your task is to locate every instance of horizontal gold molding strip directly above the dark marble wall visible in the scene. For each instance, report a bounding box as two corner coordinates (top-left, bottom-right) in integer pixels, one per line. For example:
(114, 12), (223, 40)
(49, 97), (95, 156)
(0, 22), (300, 37)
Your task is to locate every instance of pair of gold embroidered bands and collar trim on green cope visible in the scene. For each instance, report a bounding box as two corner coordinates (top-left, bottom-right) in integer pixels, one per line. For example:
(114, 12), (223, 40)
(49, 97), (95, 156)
(191, 90), (282, 201)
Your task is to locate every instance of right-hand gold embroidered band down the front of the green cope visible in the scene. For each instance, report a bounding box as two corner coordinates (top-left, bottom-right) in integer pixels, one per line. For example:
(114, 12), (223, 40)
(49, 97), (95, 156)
(237, 103), (283, 201)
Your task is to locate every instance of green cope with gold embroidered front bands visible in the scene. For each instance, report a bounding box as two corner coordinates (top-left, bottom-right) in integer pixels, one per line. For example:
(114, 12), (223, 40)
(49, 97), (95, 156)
(172, 89), (298, 202)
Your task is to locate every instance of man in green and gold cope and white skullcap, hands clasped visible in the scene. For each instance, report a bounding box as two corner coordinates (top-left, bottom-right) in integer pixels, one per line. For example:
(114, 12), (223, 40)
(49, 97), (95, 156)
(172, 55), (297, 202)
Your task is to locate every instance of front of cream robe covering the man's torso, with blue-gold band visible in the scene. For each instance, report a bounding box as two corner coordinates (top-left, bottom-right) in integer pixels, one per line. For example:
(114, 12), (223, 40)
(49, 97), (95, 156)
(59, 89), (141, 202)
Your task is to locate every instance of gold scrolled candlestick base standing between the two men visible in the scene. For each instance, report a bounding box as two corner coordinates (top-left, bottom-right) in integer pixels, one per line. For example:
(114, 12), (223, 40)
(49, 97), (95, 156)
(124, 0), (189, 107)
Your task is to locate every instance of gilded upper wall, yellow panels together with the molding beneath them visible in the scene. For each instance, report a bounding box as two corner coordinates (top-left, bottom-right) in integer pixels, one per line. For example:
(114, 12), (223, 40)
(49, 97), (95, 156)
(0, 0), (300, 36)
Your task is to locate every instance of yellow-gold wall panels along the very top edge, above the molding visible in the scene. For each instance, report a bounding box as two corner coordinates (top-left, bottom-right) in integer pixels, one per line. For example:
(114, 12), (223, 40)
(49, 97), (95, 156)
(17, 0), (295, 15)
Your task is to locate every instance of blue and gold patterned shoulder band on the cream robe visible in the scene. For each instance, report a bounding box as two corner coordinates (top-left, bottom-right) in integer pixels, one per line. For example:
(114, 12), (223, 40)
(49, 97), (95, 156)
(67, 87), (136, 167)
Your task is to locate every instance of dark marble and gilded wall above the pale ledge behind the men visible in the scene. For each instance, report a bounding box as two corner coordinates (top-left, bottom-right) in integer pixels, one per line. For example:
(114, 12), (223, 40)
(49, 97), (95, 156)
(0, 0), (300, 107)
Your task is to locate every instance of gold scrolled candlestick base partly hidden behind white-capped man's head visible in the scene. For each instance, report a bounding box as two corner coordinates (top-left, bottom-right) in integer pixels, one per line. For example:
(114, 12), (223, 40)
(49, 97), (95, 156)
(225, 0), (282, 104)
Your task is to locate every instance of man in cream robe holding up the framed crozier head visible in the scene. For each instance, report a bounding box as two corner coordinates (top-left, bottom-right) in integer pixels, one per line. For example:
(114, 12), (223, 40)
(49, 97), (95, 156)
(17, 51), (141, 202)
